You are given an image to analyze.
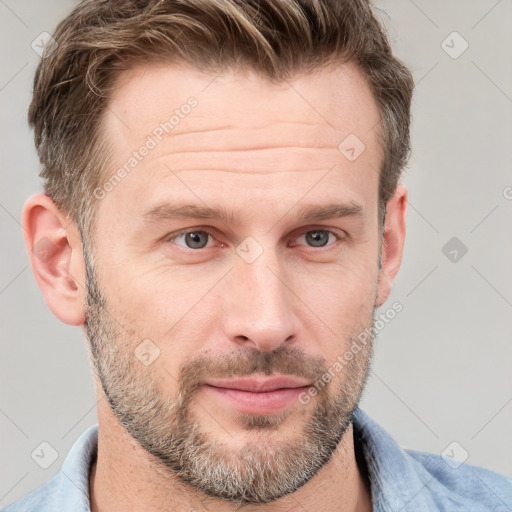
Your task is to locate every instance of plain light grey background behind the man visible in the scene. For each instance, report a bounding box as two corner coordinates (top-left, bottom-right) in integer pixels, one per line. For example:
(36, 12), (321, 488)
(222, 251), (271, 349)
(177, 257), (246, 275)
(0, 0), (512, 506)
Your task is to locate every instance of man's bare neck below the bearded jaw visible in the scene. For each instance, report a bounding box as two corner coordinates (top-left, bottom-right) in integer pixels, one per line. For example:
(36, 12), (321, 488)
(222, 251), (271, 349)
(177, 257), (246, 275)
(90, 403), (372, 512)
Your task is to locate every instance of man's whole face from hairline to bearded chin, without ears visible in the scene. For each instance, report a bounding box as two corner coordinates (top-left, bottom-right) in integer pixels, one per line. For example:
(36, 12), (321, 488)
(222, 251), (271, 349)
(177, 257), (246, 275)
(86, 64), (382, 502)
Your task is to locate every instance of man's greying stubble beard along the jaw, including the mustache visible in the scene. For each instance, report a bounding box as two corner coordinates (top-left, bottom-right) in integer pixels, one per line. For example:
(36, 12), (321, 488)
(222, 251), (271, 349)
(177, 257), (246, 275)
(85, 252), (373, 504)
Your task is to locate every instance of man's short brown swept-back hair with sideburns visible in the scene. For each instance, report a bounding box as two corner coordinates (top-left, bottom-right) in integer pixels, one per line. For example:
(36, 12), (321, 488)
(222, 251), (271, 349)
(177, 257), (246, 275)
(28, 0), (413, 240)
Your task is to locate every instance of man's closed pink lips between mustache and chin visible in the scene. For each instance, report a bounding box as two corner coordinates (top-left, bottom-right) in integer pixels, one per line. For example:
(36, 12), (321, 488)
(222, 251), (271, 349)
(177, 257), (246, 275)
(203, 376), (312, 415)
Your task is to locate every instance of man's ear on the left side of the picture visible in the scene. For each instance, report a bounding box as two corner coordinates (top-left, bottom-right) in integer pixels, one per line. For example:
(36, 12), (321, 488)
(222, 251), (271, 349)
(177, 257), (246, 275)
(22, 194), (86, 325)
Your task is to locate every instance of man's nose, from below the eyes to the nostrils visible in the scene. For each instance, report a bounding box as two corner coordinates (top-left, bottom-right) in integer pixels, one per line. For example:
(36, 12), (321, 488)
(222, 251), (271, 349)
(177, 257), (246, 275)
(223, 249), (297, 352)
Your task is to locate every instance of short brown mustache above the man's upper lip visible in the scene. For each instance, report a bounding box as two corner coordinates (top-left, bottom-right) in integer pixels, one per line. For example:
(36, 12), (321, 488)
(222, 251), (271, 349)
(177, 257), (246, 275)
(178, 345), (328, 395)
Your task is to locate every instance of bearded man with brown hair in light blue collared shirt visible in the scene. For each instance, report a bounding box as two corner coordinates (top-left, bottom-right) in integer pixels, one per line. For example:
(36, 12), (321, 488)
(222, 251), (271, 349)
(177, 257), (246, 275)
(6, 0), (512, 512)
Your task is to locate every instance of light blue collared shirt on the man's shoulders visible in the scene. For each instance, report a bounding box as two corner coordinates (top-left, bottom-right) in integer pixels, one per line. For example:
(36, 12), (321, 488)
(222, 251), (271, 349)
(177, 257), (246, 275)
(4, 409), (512, 512)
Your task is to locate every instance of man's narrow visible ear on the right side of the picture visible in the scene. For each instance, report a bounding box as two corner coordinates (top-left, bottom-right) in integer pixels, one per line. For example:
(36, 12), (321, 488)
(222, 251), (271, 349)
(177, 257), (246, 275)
(377, 185), (407, 306)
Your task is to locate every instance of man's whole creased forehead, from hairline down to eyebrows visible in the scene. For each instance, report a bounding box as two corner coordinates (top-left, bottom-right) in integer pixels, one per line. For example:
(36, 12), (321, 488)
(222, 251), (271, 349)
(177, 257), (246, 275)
(98, 63), (381, 226)
